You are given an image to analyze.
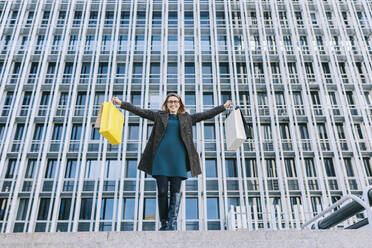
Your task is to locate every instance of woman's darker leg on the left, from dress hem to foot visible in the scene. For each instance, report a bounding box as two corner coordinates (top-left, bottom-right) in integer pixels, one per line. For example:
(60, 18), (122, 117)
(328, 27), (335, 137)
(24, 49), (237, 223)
(156, 176), (168, 231)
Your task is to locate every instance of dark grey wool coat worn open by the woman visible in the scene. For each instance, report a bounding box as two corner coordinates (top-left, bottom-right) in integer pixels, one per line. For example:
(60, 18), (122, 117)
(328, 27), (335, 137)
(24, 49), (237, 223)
(120, 102), (225, 177)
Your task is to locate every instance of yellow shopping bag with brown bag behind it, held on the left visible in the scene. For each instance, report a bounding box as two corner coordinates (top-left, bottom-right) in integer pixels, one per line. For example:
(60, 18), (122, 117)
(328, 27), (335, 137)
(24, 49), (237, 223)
(94, 102), (124, 145)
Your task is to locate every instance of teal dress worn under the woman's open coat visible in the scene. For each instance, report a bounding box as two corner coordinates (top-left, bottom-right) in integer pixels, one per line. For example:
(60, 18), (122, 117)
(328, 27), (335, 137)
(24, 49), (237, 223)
(152, 114), (187, 179)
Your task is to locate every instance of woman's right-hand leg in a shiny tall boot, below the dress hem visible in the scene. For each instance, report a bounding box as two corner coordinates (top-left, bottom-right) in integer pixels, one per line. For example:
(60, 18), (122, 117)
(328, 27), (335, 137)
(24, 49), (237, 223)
(168, 177), (182, 230)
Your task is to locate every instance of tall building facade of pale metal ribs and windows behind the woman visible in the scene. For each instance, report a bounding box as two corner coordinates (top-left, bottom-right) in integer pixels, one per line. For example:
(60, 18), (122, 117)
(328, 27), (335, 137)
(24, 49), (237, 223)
(0, 0), (372, 233)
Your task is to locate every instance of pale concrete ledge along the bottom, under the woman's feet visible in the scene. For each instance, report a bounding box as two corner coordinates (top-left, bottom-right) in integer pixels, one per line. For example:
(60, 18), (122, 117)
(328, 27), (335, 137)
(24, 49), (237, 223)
(0, 230), (372, 248)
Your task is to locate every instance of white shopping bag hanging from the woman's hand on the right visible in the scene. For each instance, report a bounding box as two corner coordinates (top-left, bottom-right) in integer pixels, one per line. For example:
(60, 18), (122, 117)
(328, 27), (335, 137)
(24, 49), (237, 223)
(225, 108), (247, 151)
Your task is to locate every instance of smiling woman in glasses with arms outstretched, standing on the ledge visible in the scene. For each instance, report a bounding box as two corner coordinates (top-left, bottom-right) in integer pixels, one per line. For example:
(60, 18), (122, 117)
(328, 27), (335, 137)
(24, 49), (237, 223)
(112, 93), (231, 231)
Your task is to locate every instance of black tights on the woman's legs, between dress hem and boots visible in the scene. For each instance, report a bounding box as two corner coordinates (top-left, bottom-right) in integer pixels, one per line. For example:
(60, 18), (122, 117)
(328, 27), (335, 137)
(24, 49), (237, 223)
(156, 176), (182, 220)
